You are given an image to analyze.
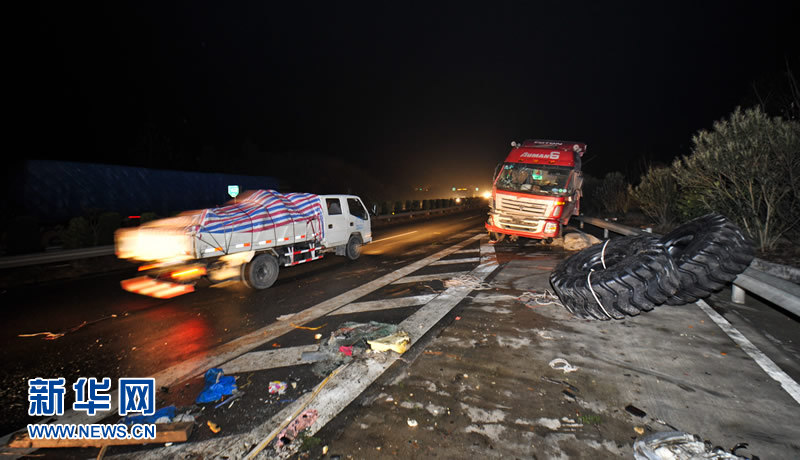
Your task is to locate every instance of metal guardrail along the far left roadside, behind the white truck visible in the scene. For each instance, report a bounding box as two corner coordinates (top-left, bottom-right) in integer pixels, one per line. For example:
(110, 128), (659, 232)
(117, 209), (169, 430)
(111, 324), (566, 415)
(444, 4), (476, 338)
(0, 206), (482, 270)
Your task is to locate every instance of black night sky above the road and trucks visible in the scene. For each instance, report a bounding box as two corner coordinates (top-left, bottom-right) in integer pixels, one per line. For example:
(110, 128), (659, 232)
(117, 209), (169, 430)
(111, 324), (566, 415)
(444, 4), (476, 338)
(5, 1), (800, 195)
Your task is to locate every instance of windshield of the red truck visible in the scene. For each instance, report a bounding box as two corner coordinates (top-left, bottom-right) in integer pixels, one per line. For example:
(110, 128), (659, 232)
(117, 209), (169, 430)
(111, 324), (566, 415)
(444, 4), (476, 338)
(495, 163), (572, 195)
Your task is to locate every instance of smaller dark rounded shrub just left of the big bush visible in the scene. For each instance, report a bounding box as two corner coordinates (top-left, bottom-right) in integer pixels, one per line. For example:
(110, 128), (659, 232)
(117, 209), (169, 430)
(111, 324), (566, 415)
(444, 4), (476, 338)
(628, 167), (678, 228)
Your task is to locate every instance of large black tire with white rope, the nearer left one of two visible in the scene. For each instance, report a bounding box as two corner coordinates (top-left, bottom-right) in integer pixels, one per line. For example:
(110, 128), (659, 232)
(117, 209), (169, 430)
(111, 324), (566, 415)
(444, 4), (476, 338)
(550, 236), (679, 320)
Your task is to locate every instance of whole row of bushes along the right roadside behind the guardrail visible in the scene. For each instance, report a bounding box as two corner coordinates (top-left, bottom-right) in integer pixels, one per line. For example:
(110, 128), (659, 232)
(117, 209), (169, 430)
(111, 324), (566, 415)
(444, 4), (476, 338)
(596, 107), (800, 265)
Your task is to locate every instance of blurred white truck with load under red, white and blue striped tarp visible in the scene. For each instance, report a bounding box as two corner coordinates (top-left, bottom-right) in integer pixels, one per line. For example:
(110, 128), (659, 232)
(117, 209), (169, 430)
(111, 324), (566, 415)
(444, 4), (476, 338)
(115, 190), (372, 298)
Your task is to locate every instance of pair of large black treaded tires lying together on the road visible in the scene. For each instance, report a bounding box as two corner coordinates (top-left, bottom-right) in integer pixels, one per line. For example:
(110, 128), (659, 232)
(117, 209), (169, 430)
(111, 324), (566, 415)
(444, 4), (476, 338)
(550, 214), (754, 320)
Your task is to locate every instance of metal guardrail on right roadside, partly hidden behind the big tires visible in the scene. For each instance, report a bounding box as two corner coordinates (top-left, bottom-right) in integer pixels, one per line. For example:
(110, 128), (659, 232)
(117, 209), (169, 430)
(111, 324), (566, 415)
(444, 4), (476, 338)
(574, 216), (800, 316)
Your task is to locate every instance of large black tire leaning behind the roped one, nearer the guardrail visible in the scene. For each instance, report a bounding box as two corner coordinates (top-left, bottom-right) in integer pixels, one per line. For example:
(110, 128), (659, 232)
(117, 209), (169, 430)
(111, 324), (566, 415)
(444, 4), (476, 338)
(661, 214), (755, 305)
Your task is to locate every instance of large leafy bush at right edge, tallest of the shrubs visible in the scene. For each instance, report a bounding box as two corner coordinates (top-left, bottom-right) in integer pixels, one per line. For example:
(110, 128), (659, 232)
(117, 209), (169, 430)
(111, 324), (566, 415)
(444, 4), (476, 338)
(673, 107), (800, 250)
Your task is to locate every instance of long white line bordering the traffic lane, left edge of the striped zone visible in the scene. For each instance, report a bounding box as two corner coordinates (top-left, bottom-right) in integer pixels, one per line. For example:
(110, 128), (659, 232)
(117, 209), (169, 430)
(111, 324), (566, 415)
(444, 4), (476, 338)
(9, 233), (484, 438)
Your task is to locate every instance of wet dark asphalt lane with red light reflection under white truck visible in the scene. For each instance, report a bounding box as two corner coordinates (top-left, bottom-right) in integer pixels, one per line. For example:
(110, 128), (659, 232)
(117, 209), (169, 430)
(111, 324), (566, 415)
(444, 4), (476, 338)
(0, 210), (485, 435)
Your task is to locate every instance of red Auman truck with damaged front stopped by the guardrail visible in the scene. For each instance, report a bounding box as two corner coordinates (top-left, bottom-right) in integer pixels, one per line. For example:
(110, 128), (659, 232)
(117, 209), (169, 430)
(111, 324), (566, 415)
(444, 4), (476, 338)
(486, 139), (586, 242)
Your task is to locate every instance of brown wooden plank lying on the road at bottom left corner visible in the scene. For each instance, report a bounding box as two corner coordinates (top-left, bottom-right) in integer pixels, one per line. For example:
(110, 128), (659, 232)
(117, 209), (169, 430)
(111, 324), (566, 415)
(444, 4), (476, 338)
(7, 422), (194, 449)
